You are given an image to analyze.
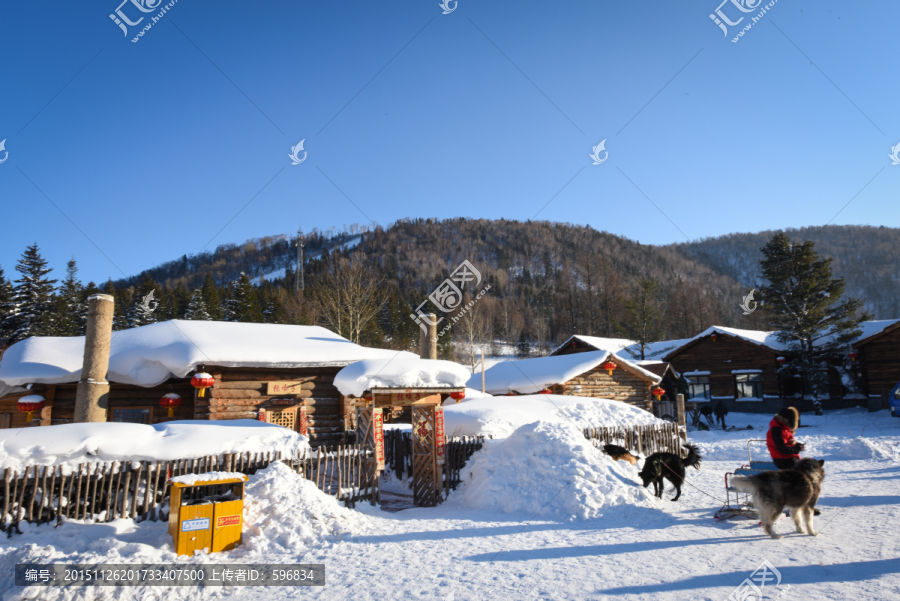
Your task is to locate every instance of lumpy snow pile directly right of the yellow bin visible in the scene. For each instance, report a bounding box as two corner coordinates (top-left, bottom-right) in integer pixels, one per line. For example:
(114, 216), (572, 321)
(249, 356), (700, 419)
(237, 461), (367, 559)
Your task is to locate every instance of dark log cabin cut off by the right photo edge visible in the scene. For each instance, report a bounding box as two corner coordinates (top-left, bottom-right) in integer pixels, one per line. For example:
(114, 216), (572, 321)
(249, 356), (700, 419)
(852, 319), (900, 409)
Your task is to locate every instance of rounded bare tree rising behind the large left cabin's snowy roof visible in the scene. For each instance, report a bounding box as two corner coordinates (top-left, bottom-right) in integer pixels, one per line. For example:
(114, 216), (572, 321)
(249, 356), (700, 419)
(310, 254), (388, 344)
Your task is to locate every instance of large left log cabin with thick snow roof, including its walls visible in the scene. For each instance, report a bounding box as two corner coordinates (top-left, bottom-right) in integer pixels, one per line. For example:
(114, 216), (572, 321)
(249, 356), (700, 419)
(0, 320), (395, 446)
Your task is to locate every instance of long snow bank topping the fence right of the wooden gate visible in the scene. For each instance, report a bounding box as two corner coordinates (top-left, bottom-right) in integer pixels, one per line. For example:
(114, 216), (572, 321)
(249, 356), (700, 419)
(444, 394), (665, 438)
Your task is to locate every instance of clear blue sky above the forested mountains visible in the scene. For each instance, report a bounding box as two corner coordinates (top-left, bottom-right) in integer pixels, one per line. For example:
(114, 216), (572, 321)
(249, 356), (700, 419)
(0, 0), (900, 282)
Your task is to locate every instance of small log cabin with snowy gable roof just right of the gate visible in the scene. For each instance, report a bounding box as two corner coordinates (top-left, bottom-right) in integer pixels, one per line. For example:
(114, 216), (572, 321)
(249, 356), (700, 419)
(467, 351), (661, 411)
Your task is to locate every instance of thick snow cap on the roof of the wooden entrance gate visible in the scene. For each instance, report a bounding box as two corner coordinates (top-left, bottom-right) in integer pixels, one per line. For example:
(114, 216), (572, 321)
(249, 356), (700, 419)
(334, 351), (472, 397)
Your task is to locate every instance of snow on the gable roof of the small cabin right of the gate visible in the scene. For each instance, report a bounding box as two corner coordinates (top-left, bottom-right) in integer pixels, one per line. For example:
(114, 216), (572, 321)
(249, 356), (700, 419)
(467, 351), (660, 394)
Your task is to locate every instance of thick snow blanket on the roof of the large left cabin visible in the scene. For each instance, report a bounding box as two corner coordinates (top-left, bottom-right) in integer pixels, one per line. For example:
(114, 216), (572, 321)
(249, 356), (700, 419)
(0, 320), (394, 386)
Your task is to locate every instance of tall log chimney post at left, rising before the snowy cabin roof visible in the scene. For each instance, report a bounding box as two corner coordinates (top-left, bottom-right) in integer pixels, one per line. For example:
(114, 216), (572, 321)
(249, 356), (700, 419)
(75, 294), (115, 423)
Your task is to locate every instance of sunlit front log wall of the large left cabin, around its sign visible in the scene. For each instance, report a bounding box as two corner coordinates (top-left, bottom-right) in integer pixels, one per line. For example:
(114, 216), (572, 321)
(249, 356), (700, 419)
(202, 366), (345, 447)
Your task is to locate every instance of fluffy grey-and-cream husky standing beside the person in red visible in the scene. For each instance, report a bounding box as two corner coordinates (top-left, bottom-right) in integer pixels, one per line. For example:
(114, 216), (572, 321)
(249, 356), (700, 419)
(731, 459), (825, 539)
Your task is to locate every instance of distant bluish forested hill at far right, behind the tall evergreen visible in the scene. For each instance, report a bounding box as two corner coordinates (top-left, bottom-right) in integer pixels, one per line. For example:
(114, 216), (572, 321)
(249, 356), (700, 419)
(667, 225), (900, 319)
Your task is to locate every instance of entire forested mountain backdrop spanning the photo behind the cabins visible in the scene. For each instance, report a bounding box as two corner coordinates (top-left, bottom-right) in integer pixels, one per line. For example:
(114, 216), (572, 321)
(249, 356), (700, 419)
(0, 219), (900, 361)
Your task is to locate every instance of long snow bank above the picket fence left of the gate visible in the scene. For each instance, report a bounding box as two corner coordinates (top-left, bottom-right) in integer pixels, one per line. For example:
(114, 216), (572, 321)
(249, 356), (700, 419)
(0, 419), (309, 471)
